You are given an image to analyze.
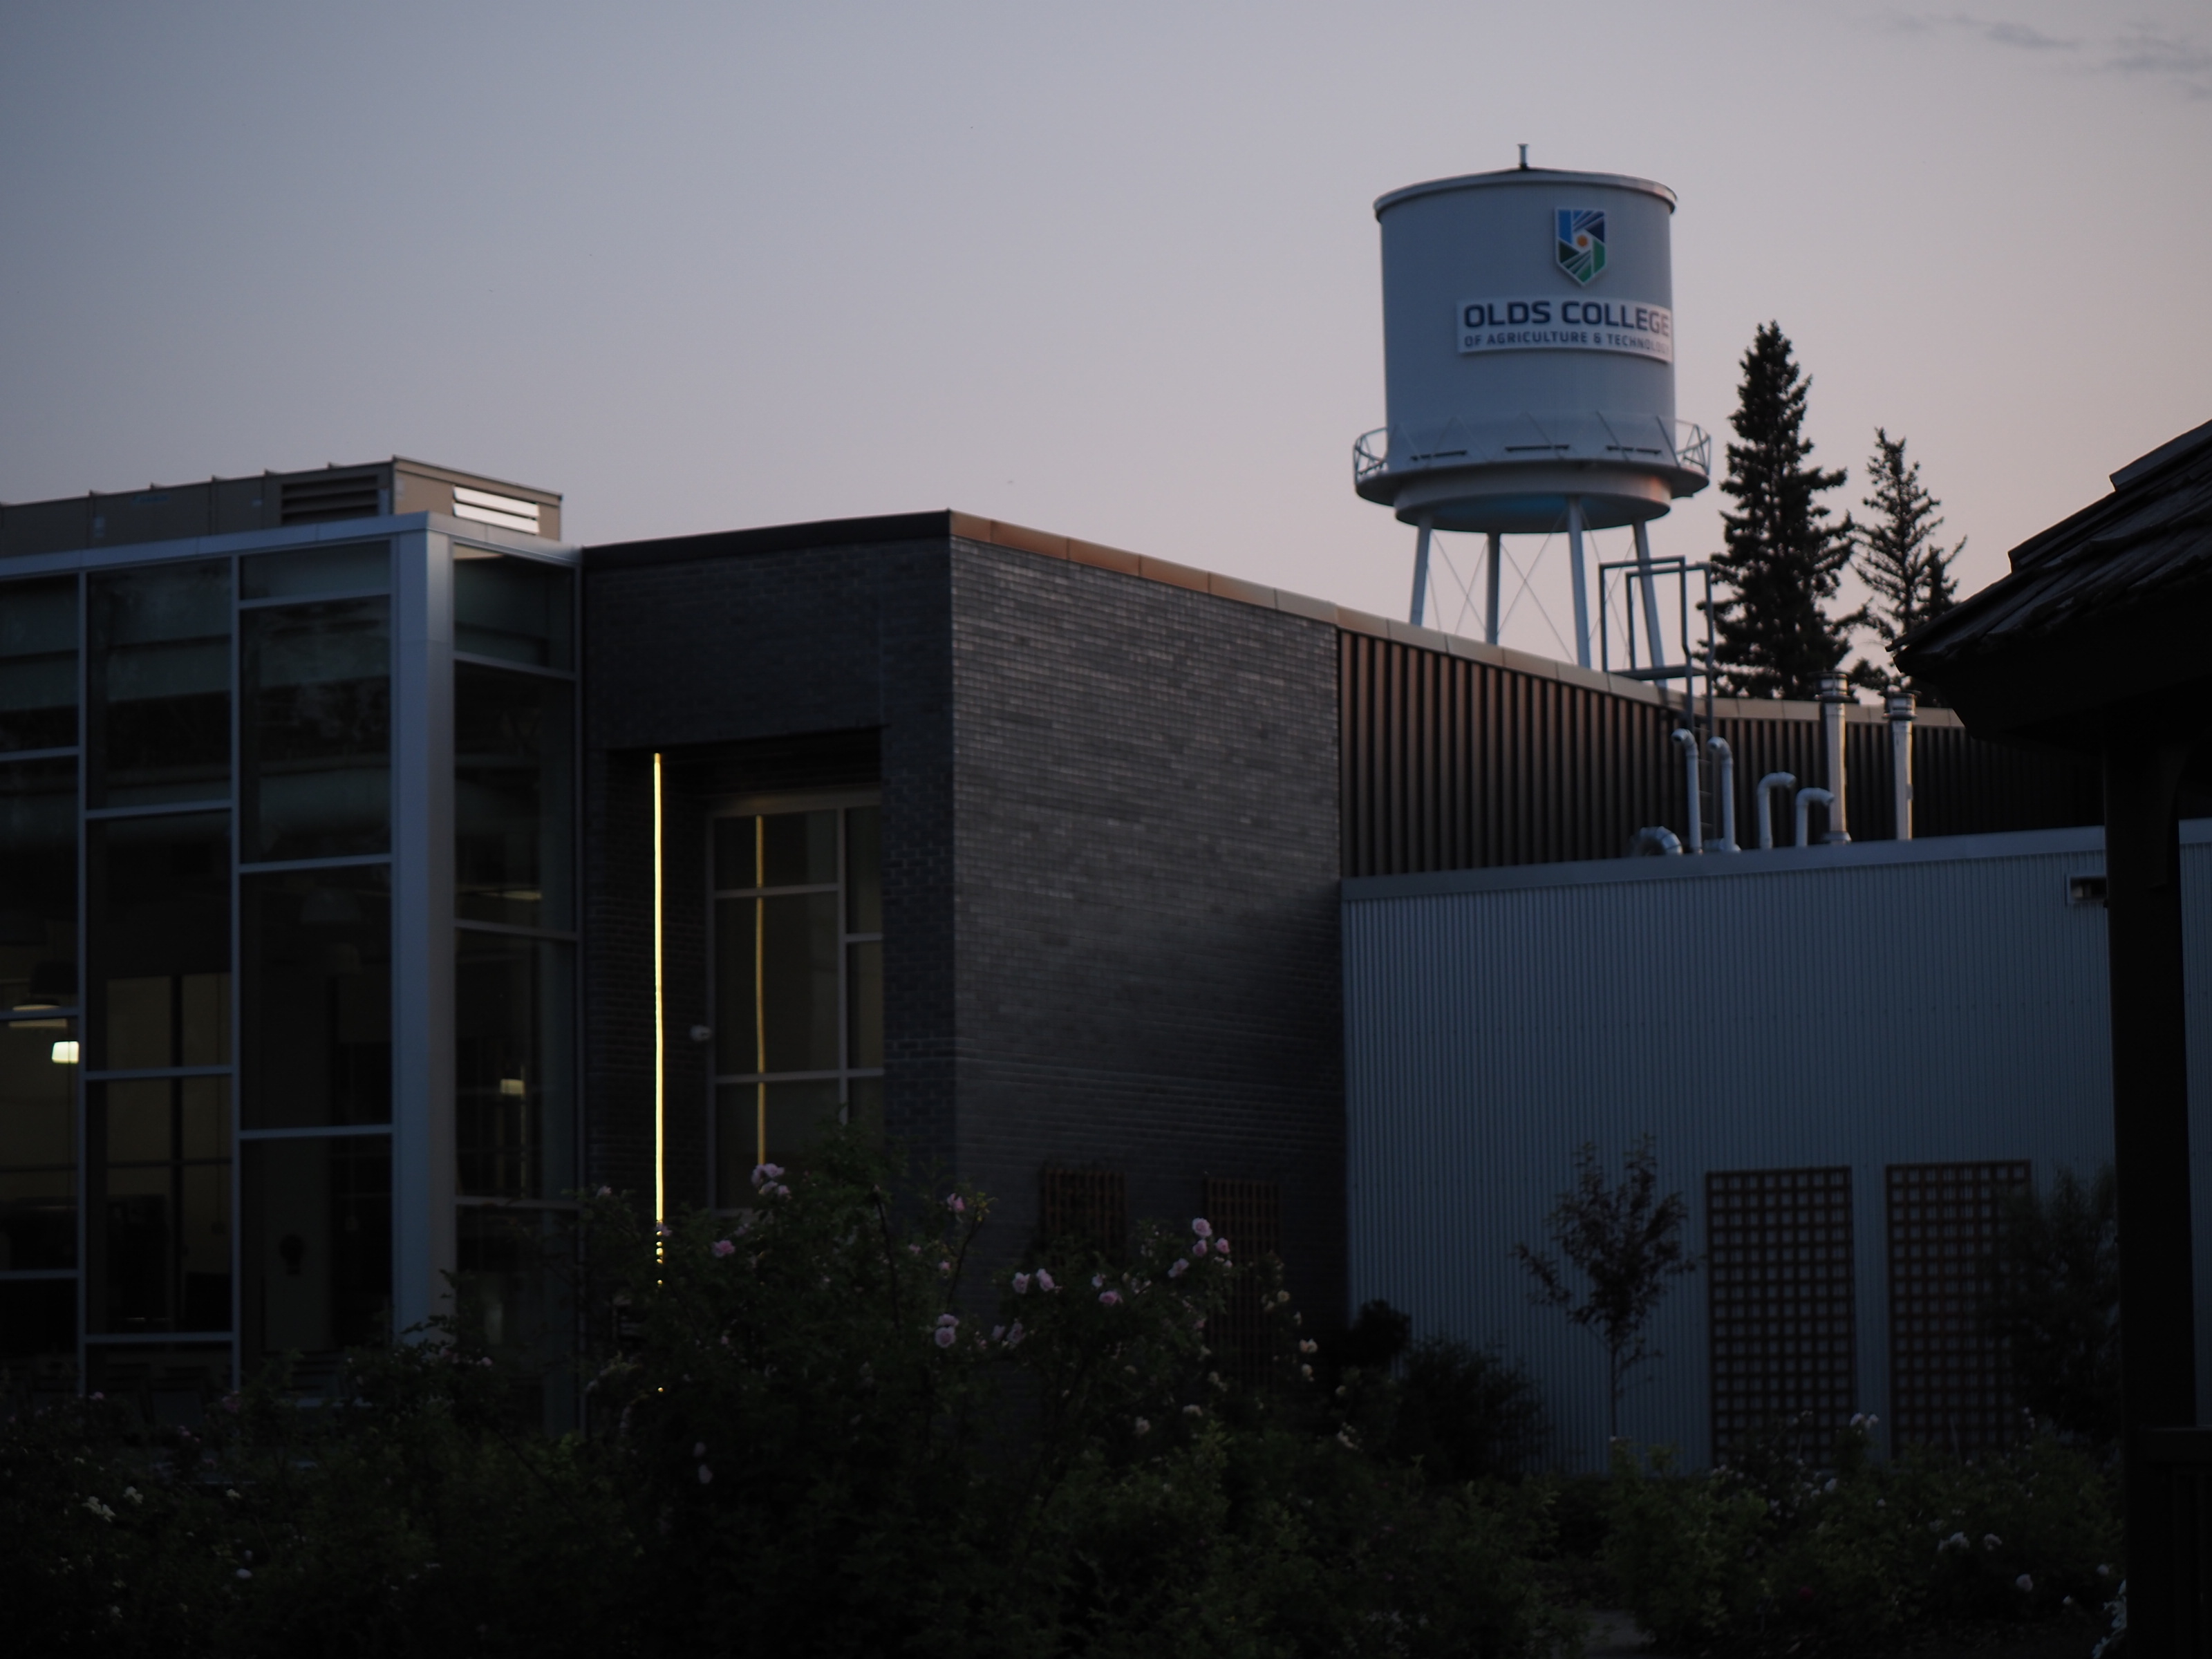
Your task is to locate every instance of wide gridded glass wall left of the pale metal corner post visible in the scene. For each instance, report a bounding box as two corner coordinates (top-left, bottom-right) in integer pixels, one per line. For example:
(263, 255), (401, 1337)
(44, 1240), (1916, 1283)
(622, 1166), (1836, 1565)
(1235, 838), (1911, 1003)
(0, 553), (391, 1412)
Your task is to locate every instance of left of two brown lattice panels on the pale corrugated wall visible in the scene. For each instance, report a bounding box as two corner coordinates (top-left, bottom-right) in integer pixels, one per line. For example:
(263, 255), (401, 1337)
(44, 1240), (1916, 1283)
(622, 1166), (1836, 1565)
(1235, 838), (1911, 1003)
(1705, 1168), (1858, 1458)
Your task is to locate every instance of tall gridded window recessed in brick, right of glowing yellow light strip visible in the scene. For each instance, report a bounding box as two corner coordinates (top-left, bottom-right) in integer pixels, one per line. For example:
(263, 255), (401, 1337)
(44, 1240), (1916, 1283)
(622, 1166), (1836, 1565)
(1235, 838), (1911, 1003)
(710, 803), (883, 1206)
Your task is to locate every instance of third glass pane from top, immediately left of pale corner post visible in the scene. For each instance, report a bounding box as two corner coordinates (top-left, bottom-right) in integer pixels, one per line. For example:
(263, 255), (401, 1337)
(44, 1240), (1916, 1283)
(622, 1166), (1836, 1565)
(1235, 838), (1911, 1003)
(239, 865), (391, 1128)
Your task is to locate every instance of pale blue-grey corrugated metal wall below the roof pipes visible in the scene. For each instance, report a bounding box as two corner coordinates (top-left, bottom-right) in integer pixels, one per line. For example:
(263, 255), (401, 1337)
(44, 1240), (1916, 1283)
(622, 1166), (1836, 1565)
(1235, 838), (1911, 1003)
(1345, 825), (2212, 1467)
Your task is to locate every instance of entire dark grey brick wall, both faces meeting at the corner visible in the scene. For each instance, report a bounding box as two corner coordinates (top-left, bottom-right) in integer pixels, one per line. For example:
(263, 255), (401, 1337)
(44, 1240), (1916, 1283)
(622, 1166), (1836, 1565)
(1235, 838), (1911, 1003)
(584, 533), (1342, 1318)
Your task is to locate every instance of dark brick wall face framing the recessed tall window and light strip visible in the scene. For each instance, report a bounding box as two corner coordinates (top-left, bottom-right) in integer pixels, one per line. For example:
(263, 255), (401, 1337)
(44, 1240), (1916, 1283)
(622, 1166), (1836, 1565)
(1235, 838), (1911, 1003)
(584, 538), (953, 1201)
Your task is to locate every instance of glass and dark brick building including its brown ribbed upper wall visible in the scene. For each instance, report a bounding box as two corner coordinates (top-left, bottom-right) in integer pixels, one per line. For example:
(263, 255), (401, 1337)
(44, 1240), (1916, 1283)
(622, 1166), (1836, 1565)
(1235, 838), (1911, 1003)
(0, 460), (2097, 1423)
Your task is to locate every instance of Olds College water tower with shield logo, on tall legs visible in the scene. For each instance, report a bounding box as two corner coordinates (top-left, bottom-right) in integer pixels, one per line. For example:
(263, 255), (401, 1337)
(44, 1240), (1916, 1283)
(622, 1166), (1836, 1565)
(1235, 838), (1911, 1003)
(1353, 146), (1712, 666)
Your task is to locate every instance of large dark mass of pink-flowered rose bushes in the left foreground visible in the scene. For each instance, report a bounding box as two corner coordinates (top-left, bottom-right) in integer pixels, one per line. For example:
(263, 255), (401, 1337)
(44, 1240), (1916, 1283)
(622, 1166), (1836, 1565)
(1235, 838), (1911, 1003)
(0, 1137), (1575, 1659)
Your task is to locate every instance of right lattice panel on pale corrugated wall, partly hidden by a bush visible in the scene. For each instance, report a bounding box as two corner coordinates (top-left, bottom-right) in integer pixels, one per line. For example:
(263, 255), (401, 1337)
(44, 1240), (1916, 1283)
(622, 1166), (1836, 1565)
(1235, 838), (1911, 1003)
(1887, 1161), (2031, 1453)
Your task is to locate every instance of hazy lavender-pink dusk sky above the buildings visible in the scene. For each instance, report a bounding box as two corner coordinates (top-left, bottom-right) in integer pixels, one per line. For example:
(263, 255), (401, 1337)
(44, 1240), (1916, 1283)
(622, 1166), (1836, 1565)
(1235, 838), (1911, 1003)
(0, 0), (2212, 655)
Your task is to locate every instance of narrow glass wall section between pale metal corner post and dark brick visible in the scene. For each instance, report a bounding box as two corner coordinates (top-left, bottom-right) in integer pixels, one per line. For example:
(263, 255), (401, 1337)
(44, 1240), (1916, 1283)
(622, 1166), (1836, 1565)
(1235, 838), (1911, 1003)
(453, 546), (577, 1429)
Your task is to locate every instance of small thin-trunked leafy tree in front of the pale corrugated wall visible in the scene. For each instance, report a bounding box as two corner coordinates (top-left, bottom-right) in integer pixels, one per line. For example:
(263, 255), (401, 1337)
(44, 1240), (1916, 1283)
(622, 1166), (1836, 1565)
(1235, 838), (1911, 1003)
(1513, 1135), (1696, 1440)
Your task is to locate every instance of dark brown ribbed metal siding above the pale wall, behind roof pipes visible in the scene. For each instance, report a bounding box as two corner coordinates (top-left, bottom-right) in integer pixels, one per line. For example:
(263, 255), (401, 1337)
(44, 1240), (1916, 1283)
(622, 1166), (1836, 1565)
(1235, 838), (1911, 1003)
(1338, 630), (2103, 876)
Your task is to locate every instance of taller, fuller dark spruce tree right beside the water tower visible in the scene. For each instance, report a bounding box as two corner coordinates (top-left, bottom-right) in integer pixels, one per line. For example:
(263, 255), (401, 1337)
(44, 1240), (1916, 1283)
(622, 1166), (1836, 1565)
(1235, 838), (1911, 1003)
(1712, 323), (1860, 697)
